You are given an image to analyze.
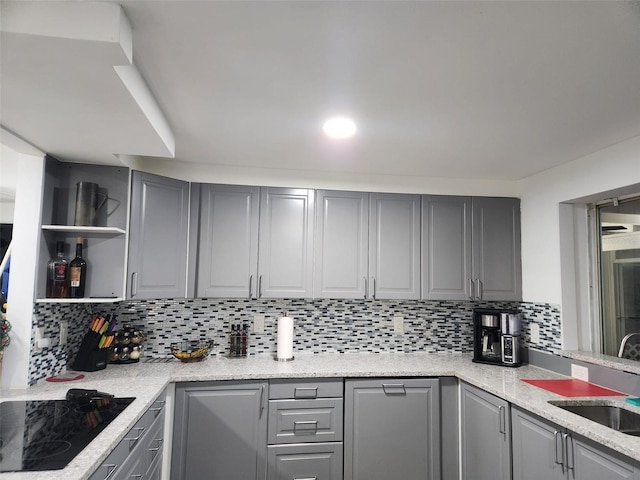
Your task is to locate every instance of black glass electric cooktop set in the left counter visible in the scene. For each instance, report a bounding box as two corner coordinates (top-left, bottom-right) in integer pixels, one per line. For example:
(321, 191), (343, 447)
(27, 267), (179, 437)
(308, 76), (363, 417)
(0, 398), (134, 472)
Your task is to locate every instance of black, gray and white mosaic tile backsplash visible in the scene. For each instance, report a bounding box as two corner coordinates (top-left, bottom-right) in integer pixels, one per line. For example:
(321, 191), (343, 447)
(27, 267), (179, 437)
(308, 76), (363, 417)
(29, 298), (560, 384)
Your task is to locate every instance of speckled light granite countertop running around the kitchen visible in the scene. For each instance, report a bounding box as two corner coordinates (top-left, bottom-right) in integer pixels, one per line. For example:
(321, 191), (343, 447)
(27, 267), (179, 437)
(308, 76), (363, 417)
(0, 353), (640, 480)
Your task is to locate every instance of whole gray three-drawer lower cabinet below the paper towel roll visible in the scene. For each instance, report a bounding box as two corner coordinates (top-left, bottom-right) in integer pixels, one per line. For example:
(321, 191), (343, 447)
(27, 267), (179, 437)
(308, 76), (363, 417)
(267, 379), (344, 480)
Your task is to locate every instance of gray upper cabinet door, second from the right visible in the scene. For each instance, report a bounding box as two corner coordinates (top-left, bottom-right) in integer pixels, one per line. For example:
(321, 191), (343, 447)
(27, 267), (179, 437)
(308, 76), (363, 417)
(422, 195), (473, 300)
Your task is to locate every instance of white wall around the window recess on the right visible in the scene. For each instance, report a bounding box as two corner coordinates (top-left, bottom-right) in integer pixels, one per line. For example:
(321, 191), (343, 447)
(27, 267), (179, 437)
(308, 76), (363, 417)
(521, 133), (640, 349)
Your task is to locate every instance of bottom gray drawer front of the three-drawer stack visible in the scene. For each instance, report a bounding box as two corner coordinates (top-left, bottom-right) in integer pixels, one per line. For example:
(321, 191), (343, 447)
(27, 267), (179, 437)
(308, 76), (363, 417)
(267, 443), (342, 480)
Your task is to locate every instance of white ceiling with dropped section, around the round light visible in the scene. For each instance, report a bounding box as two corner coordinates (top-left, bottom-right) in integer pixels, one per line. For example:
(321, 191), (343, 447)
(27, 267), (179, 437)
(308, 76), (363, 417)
(0, 0), (640, 180)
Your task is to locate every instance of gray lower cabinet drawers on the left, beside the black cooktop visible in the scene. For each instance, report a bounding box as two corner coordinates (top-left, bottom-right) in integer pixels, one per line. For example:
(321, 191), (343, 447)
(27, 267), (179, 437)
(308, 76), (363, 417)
(90, 393), (165, 480)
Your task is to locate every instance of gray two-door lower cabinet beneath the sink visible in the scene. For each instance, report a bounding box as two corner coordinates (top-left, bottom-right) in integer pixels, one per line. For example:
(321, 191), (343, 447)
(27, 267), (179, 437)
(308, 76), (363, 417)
(511, 407), (640, 480)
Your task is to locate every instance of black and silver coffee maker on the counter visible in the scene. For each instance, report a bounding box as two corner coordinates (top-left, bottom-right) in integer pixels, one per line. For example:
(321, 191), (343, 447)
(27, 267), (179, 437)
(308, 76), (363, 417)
(473, 308), (522, 367)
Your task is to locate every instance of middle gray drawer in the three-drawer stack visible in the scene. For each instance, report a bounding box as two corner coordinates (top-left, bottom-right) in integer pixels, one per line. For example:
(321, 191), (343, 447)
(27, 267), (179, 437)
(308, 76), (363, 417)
(268, 398), (343, 445)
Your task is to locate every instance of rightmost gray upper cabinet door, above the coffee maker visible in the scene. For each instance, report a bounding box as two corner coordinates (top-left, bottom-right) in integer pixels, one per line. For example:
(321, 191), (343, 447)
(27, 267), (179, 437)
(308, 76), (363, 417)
(473, 198), (522, 301)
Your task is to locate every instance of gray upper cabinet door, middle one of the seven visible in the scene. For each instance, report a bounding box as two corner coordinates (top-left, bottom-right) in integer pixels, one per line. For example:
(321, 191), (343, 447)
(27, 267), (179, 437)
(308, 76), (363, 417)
(314, 190), (369, 298)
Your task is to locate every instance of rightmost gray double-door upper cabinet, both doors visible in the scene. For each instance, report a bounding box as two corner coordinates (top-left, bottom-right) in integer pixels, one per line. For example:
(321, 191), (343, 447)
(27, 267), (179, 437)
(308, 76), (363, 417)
(422, 195), (522, 301)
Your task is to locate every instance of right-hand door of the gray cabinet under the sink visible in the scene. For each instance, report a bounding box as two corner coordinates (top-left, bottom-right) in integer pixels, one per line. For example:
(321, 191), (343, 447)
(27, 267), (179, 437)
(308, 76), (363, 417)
(567, 436), (638, 480)
